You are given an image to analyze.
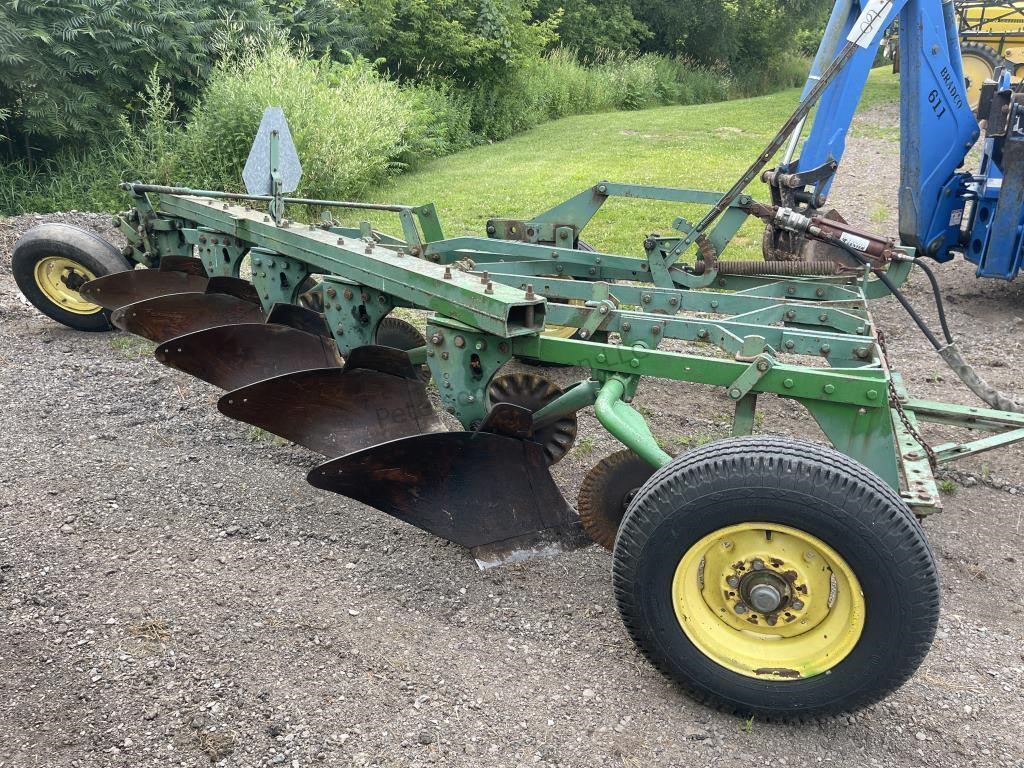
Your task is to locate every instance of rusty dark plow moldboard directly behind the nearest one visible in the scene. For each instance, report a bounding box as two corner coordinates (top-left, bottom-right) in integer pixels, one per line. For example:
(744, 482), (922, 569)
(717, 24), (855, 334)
(217, 346), (444, 457)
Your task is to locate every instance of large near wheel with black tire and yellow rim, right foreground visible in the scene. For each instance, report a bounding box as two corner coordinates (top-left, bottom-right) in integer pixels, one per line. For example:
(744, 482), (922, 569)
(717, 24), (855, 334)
(614, 437), (939, 719)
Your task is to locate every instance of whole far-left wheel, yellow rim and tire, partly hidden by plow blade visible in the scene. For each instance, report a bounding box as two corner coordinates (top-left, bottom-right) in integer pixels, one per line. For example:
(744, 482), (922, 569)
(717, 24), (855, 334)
(11, 223), (131, 331)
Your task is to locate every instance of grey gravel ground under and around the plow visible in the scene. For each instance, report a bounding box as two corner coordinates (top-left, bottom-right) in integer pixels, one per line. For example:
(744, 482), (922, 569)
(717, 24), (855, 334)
(0, 103), (1024, 768)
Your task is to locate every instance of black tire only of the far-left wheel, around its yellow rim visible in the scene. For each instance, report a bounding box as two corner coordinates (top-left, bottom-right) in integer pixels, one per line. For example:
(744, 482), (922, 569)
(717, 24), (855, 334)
(11, 223), (132, 332)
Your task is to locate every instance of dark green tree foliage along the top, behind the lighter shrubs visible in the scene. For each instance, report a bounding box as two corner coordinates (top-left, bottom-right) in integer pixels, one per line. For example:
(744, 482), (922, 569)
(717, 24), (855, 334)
(0, 0), (830, 159)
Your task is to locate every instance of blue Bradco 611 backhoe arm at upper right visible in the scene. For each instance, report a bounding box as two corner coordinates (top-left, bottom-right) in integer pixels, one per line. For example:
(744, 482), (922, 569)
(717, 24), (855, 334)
(765, 0), (1024, 279)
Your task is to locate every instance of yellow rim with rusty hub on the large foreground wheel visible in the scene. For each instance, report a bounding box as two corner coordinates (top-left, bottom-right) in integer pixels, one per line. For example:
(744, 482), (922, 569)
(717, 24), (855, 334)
(672, 522), (864, 680)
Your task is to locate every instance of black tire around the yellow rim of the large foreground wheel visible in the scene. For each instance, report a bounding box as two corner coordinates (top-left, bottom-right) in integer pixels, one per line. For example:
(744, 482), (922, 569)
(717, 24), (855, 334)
(614, 437), (939, 720)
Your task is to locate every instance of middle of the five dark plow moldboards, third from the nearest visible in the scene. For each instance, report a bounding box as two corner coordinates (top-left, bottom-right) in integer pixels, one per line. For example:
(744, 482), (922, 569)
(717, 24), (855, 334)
(156, 304), (342, 390)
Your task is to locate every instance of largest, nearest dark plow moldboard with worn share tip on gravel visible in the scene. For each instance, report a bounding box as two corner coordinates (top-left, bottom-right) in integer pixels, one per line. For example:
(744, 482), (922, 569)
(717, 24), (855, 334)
(306, 432), (591, 568)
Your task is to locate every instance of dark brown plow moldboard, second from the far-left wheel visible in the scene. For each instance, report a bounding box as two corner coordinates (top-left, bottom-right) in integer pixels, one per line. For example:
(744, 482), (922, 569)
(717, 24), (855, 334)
(111, 278), (264, 344)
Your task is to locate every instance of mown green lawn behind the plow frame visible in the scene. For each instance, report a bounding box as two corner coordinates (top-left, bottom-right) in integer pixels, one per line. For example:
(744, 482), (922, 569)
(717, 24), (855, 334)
(373, 69), (898, 257)
